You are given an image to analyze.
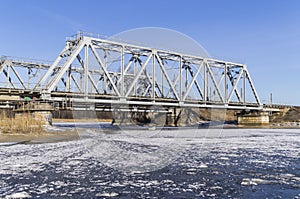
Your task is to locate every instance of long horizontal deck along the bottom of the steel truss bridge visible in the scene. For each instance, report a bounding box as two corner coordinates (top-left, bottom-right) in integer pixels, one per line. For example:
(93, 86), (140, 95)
(0, 88), (262, 110)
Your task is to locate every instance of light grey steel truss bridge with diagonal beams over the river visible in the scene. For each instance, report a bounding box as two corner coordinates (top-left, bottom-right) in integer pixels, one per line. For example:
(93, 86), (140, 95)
(0, 33), (263, 110)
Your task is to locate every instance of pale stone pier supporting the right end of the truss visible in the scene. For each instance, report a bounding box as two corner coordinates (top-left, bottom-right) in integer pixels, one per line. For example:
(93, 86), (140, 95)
(237, 111), (269, 126)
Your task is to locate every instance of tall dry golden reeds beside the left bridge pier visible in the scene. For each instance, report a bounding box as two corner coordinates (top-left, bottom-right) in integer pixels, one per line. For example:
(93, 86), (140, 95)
(0, 113), (46, 134)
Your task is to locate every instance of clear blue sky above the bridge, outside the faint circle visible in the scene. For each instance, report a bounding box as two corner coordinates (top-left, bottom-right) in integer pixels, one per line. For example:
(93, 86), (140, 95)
(0, 0), (300, 105)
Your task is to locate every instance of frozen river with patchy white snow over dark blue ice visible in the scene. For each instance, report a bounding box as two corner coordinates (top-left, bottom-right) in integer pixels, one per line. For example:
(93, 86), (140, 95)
(0, 124), (300, 198)
